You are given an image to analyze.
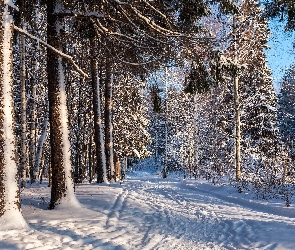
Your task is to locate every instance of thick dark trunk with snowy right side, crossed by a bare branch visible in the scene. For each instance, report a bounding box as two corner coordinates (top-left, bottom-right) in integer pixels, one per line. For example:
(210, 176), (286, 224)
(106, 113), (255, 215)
(47, 0), (78, 209)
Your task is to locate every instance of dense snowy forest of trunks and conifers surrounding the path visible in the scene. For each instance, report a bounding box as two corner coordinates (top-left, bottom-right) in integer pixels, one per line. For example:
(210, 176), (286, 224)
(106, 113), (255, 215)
(0, 0), (295, 227)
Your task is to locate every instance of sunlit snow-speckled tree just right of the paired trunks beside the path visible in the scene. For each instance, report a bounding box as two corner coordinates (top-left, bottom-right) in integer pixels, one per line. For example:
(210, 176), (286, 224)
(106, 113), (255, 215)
(114, 73), (150, 177)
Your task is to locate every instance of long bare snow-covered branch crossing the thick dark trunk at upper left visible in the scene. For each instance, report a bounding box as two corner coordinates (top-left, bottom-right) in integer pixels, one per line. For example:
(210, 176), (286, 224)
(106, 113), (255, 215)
(13, 25), (88, 78)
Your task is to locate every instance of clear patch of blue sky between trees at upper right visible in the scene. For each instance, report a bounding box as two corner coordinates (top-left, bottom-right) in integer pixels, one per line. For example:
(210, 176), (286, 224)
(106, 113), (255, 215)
(266, 20), (295, 91)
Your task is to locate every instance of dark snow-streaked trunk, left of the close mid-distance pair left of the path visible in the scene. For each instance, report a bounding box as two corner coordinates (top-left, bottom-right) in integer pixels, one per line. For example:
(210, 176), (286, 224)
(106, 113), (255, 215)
(90, 39), (108, 183)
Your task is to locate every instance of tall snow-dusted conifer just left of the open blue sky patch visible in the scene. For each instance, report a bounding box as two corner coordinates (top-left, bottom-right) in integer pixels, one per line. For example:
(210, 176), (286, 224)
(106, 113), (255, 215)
(240, 1), (280, 188)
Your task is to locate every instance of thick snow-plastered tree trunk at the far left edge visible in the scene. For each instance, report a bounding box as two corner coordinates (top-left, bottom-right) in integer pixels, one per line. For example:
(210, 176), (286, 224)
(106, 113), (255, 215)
(0, 0), (27, 230)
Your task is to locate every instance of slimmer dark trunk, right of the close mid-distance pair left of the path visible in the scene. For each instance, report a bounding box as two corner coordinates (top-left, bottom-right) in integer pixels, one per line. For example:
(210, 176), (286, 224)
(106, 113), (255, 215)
(105, 56), (115, 180)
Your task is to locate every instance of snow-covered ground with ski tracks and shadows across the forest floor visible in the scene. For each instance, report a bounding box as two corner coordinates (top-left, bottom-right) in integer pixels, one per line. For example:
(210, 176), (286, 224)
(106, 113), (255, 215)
(0, 171), (295, 250)
